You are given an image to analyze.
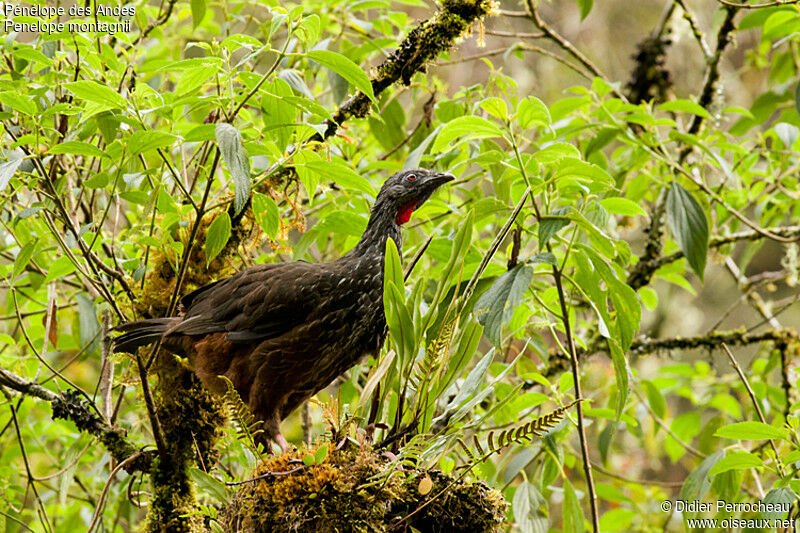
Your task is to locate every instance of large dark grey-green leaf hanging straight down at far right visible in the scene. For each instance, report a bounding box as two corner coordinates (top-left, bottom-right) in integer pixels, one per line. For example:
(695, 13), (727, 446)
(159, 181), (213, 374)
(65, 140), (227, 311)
(667, 182), (709, 281)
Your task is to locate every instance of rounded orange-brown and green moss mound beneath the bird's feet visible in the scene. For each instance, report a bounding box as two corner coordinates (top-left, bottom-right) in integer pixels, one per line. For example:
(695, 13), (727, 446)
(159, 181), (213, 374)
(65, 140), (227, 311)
(222, 444), (507, 533)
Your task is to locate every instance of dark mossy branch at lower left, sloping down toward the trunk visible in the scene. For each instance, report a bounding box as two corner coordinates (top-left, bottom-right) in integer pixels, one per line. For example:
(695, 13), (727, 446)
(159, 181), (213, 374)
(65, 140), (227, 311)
(0, 368), (154, 473)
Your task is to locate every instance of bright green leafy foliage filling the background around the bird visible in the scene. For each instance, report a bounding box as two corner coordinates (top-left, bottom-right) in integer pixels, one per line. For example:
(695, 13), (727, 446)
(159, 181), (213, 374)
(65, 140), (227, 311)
(0, 0), (800, 531)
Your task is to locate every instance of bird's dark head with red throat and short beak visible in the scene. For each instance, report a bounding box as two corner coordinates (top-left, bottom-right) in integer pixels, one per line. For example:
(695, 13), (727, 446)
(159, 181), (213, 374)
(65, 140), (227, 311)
(375, 168), (455, 225)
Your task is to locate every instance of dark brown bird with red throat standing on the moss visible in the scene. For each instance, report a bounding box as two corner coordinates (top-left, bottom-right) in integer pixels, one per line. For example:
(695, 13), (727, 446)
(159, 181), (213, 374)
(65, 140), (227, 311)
(114, 169), (454, 451)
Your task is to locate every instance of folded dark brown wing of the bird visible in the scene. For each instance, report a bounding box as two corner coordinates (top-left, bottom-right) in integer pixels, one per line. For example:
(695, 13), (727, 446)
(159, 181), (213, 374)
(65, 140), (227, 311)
(169, 261), (338, 342)
